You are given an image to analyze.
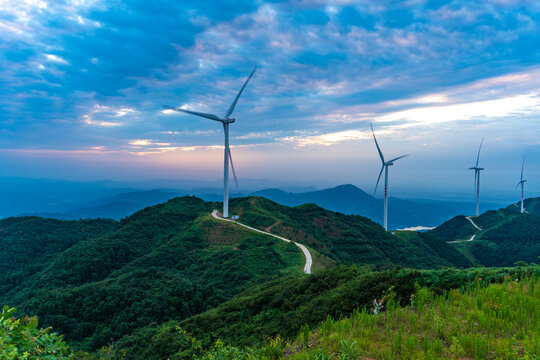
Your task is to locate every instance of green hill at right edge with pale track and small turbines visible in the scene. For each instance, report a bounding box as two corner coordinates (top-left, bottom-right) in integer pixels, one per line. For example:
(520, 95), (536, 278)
(429, 198), (540, 266)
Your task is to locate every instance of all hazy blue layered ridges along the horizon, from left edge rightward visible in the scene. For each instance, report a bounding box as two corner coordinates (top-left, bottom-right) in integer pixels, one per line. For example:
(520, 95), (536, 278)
(0, 178), (510, 229)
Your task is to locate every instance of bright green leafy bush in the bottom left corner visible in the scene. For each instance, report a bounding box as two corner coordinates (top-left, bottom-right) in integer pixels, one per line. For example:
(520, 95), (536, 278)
(0, 306), (74, 360)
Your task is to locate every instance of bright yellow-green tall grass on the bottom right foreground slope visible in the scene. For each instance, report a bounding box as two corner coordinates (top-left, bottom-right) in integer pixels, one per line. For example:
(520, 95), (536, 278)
(283, 276), (540, 360)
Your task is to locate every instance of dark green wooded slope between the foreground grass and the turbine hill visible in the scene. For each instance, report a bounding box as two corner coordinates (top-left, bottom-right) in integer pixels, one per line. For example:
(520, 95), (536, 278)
(109, 266), (540, 360)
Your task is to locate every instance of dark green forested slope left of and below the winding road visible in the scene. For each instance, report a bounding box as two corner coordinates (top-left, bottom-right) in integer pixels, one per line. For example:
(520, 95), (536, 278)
(0, 197), (304, 350)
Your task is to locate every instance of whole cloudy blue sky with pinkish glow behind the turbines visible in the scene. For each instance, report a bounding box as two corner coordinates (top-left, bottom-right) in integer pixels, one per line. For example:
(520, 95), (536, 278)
(0, 0), (540, 196)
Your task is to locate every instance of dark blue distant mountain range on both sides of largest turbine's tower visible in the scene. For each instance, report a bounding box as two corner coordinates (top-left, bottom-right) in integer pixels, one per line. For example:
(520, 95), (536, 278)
(17, 185), (506, 229)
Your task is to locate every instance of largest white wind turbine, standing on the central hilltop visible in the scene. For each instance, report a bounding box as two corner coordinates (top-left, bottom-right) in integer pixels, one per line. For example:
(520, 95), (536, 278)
(163, 68), (257, 217)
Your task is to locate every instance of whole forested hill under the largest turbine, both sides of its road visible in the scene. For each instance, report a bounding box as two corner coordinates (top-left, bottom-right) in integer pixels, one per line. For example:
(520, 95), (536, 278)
(0, 197), (470, 350)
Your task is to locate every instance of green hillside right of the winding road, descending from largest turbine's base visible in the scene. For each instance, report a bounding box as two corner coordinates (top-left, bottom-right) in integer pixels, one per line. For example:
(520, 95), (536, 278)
(231, 197), (470, 268)
